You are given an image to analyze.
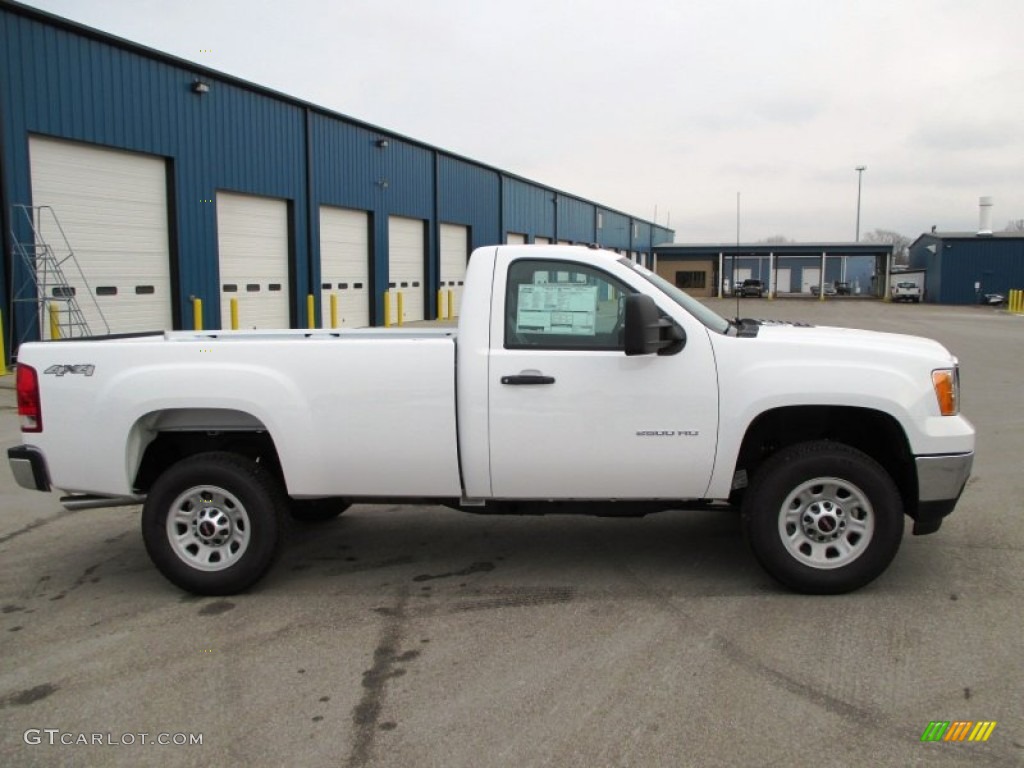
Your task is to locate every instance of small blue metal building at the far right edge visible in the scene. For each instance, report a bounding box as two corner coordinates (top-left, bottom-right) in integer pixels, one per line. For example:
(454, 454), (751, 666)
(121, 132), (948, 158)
(910, 232), (1024, 304)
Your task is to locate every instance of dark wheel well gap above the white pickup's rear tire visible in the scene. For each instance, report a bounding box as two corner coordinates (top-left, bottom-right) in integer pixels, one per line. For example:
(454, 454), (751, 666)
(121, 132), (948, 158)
(134, 430), (284, 494)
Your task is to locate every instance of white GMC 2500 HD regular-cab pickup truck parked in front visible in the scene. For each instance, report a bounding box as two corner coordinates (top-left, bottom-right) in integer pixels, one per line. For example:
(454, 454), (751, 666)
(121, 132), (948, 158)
(8, 246), (975, 594)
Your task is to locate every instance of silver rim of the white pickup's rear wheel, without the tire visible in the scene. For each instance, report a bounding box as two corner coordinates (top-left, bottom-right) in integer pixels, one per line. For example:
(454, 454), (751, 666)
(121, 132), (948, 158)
(167, 485), (252, 570)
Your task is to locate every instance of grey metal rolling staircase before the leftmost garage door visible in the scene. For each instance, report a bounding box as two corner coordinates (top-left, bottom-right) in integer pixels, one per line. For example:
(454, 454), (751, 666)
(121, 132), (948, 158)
(11, 205), (111, 348)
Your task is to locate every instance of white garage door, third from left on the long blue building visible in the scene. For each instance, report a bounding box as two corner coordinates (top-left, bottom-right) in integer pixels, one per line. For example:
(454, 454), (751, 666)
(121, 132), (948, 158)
(321, 206), (370, 328)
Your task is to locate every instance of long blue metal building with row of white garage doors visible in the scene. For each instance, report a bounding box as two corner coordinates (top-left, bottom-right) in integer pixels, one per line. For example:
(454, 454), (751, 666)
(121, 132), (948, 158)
(0, 0), (674, 353)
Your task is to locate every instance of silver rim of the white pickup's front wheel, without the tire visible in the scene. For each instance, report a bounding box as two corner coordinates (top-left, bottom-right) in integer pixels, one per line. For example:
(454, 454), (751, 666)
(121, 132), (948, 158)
(778, 477), (874, 570)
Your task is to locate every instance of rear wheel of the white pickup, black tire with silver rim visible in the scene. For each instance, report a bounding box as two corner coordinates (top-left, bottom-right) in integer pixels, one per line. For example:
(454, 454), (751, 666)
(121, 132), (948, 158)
(142, 452), (288, 595)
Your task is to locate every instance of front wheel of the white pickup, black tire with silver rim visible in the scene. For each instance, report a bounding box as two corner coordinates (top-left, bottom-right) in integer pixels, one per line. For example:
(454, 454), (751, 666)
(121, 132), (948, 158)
(743, 440), (903, 595)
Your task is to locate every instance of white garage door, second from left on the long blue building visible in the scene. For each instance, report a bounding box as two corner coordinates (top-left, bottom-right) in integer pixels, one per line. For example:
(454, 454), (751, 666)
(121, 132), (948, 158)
(217, 191), (291, 329)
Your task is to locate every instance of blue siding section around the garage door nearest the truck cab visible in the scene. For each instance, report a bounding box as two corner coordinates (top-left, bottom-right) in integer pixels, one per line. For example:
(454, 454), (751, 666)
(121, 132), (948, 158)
(437, 155), (502, 249)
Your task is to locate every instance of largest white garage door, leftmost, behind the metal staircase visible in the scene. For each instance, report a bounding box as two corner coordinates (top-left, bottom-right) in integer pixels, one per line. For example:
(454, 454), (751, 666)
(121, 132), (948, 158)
(29, 136), (172, 338)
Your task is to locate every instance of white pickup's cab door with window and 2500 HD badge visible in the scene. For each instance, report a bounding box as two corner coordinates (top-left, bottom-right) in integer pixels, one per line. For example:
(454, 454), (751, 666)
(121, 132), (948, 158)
(487, 254), (718, 499)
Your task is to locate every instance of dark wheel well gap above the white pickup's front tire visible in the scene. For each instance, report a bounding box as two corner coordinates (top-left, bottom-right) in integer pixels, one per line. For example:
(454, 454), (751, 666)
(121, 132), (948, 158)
(736, 406), (918, 513)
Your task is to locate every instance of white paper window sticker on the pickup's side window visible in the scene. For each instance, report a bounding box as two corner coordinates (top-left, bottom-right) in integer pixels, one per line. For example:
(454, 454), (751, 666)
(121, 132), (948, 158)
(516, 283), (597, 336)
